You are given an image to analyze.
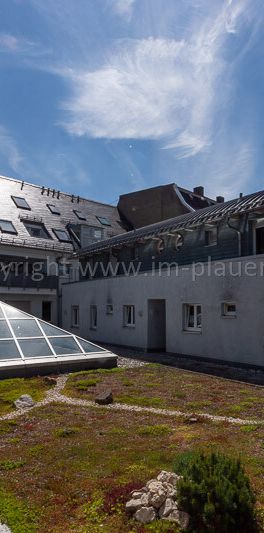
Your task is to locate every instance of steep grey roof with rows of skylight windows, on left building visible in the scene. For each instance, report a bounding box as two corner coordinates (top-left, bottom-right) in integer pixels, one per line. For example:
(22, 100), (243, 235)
(0, 176), (125, 253)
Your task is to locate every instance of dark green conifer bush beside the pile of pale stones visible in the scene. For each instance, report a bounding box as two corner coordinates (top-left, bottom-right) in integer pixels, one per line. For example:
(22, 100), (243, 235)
(175, 453), (257, 533)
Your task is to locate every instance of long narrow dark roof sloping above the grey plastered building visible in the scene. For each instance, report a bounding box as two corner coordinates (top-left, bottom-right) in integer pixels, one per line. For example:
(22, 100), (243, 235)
(79, 191), (264, 256)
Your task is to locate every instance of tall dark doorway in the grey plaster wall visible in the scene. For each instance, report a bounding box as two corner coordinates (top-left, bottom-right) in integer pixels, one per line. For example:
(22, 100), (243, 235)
(148, 300), (166, 352)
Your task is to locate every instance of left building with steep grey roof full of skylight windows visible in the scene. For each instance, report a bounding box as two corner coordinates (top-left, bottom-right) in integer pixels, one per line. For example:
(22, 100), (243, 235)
(0, 176), (126, 324)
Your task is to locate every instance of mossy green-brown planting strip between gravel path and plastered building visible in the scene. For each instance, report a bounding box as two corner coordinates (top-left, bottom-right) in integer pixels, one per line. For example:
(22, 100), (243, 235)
(64, 364), (264, 419)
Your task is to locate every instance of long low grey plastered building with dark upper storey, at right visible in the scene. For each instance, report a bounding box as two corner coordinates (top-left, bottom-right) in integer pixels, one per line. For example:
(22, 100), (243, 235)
(62, 188), (264, 367)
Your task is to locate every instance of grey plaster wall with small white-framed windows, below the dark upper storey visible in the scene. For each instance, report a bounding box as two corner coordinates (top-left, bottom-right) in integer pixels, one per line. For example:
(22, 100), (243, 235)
(62, 256), (264, 366)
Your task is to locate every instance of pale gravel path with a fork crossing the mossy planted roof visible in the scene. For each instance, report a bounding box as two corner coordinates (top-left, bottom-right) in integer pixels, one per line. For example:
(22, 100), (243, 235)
(0, 368), (264, 426)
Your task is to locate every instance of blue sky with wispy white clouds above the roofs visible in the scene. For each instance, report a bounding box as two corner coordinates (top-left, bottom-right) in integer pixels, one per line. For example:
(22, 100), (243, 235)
(0, 0), (264, 204)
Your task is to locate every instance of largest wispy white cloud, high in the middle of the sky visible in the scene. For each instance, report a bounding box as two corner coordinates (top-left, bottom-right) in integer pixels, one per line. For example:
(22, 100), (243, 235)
(61, 0), (252, 158)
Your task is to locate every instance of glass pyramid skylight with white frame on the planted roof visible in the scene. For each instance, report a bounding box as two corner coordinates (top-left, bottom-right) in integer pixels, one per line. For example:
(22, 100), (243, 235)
(0, 302), (116, 378)
